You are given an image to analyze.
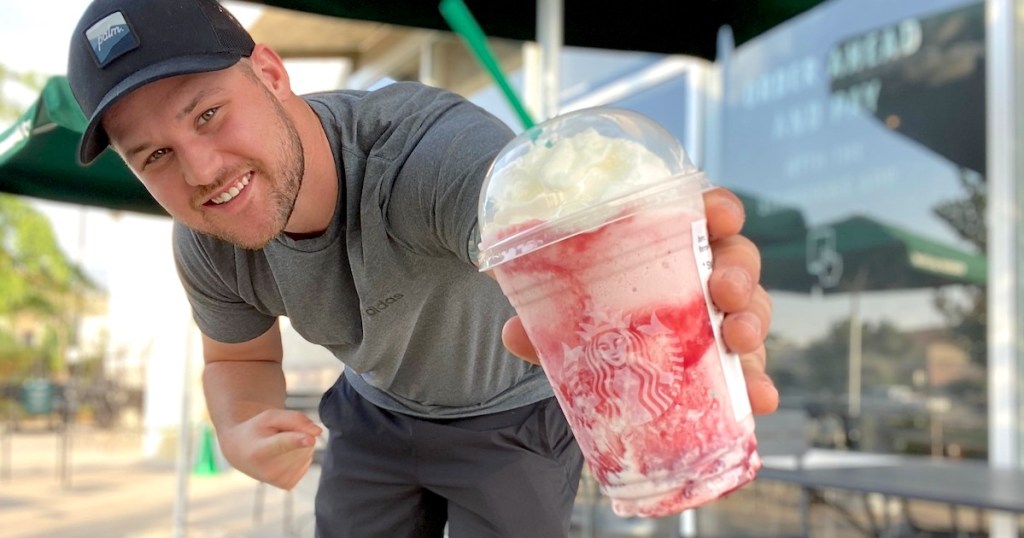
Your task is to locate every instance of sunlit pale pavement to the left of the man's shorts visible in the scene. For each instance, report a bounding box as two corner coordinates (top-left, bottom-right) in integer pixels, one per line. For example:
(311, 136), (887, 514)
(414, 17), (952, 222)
(0, 430), (318, 538)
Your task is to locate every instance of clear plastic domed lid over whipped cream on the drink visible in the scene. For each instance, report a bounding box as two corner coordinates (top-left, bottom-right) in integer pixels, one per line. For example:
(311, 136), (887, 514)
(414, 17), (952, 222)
(478, 107), (707, 271)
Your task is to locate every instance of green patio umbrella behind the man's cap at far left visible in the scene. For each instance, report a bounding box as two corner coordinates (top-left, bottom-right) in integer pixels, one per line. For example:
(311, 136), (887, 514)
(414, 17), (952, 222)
(0, 77), (167, 215)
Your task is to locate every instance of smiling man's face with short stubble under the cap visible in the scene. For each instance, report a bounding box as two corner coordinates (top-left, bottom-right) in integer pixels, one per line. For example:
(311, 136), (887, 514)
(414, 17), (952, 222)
(103, 65), (304, 249)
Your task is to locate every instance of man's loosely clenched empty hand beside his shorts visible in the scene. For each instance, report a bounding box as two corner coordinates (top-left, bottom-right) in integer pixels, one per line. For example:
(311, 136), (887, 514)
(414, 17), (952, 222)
(219, 409), (322, 490)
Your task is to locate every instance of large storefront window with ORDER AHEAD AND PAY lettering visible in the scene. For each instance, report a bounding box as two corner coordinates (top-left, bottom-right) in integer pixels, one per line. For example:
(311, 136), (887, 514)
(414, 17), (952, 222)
(717, 0), (987, 458)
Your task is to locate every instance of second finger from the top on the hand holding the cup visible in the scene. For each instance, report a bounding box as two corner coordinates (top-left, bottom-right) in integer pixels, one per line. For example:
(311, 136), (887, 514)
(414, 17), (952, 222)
(708, 236), (761, 313)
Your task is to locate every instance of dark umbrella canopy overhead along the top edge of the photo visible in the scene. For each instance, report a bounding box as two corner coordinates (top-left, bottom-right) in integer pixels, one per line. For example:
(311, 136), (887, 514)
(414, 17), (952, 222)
(253, 0), (824, 59)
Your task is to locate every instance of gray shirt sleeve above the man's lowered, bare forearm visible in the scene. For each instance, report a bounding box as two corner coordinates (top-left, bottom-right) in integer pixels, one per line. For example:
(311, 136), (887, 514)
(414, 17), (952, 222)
(173, 222), (276, 343)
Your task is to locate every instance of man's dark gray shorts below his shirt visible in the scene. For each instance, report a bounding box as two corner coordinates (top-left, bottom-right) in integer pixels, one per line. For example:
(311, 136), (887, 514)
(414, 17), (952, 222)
(316, 376), (583, 538)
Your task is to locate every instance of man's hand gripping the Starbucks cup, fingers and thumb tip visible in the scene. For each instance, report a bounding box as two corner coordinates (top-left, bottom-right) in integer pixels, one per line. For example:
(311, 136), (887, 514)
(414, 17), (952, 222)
(502, 189), (778, 414)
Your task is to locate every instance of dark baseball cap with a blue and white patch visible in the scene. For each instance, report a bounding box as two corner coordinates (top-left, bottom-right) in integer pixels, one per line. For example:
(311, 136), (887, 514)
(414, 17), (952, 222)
(68, 0), (255, 164)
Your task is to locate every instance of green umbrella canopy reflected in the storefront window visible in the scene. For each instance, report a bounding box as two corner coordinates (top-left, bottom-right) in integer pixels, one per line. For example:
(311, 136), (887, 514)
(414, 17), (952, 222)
(761, 215), (988, 293)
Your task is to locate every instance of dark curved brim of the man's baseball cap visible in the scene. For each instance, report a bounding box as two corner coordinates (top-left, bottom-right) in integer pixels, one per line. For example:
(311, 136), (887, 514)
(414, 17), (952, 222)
(78, 53), (243, 165)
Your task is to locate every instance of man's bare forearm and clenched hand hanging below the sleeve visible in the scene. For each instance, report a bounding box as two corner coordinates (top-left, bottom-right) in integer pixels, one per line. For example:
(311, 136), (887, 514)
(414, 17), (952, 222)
(203, 323), (321, 489)
